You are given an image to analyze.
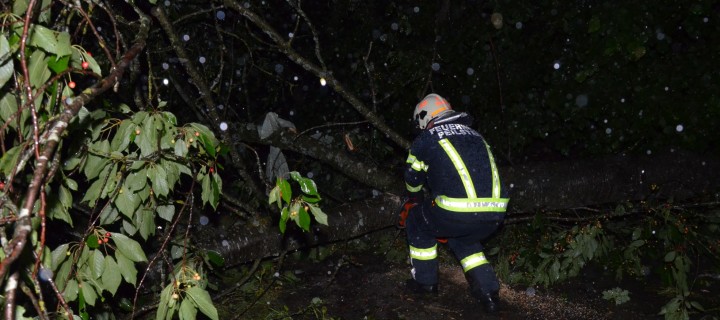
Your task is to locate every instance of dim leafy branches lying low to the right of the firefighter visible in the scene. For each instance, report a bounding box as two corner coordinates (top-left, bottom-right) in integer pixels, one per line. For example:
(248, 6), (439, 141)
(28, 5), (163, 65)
(498, 203), (720, 320)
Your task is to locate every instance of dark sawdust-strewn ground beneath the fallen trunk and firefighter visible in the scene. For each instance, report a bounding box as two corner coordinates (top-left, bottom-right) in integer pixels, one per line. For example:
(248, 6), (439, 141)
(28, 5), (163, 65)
(215, 229), (718, 320)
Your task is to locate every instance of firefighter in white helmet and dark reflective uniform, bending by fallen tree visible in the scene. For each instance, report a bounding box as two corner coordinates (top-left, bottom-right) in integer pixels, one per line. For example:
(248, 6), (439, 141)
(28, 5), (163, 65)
(401, 94), (508, 313)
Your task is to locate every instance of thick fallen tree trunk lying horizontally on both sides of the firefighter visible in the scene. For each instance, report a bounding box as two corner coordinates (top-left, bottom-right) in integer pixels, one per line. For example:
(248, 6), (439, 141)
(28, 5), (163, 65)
(195, 152), (720, 265)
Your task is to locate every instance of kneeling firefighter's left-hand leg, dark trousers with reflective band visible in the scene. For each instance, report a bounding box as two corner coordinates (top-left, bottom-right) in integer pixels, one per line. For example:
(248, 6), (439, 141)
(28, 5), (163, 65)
(405, 203), (438, 290)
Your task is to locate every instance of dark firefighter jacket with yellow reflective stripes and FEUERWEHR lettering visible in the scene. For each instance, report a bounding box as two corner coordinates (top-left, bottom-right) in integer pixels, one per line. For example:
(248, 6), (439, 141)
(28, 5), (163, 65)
(405, 112), (508, 220)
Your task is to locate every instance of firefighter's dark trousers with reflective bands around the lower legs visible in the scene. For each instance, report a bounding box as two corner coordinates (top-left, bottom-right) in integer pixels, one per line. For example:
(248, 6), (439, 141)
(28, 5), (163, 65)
(405, 200), (503, 296)
